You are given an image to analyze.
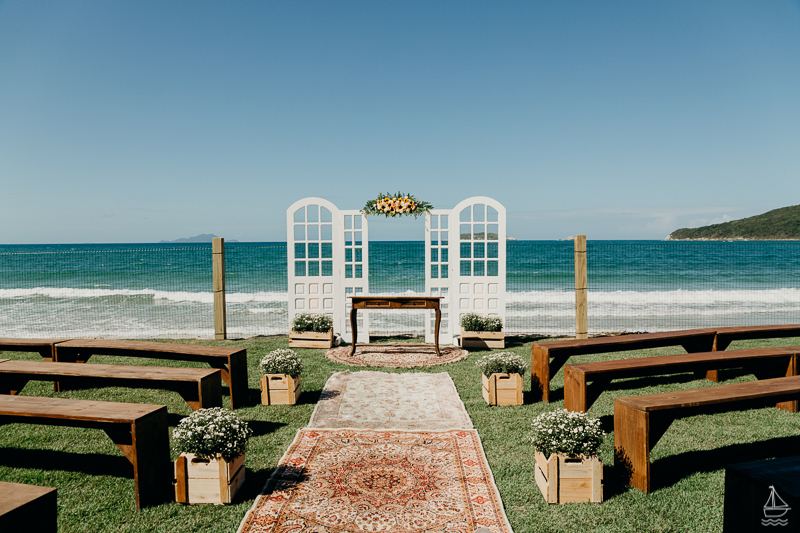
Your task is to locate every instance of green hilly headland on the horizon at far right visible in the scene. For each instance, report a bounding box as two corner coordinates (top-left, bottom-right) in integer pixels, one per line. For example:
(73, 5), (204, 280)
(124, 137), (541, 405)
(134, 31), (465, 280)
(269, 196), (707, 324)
(665, 205), (800, 241)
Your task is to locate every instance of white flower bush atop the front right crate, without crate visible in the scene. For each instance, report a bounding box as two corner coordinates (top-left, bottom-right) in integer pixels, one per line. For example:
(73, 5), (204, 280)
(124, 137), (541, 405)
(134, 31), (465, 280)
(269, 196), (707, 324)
(530, 409), (606, 457)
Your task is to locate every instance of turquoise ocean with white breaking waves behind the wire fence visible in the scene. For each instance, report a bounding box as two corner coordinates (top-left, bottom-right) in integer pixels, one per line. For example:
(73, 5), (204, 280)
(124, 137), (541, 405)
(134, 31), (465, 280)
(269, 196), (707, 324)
(0, 241), (800, 338)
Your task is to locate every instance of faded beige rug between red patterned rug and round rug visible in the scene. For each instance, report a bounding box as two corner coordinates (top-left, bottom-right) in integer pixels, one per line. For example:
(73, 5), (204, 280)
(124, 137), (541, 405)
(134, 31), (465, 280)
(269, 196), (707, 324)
(308, 371), (472, 430)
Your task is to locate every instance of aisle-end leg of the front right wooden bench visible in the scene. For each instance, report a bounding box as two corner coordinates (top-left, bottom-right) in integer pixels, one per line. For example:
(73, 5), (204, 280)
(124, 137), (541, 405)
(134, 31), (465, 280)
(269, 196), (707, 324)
(614, 401), (651, 493)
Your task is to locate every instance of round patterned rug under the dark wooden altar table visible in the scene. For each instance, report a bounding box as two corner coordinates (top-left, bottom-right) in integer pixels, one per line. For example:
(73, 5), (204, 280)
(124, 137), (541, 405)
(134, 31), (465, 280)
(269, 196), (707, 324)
(325, 343), (469, 368)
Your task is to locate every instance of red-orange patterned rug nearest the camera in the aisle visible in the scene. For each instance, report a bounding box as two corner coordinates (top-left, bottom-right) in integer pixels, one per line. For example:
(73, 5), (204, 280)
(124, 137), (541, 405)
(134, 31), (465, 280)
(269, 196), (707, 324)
(239, 429), (512, 533)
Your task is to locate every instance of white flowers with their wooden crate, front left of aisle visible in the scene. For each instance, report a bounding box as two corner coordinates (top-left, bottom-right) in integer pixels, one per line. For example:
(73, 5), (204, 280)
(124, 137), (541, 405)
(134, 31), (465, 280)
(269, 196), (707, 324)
(172, 407), (253, 505)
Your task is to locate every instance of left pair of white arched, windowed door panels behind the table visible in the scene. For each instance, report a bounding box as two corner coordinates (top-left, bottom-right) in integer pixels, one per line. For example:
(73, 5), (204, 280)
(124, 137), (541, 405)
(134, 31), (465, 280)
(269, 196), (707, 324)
(286, 198), (369, 342)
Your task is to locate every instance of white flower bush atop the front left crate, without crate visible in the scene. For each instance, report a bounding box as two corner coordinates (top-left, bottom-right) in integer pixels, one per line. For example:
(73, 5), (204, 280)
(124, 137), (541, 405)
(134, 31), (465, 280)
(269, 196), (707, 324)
(172, 407), (253, 461)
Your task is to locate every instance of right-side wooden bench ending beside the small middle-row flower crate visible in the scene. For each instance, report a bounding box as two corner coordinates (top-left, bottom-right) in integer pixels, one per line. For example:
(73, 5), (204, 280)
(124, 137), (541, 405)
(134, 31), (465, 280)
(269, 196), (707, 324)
(531, 329), (716, 402)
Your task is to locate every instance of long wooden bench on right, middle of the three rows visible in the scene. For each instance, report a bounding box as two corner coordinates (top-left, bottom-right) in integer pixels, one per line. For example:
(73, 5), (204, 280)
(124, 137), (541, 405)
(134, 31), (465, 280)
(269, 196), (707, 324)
(564, 346), (800, 413)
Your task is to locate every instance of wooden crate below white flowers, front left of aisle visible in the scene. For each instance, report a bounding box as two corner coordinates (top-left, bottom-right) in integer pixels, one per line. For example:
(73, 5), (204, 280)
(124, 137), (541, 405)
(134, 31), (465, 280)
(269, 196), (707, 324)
(175, 453), (245, 505)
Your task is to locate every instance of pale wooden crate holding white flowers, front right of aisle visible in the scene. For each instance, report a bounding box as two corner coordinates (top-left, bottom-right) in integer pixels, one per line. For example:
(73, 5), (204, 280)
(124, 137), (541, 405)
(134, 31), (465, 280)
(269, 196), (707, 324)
(535, 451), (603, 503)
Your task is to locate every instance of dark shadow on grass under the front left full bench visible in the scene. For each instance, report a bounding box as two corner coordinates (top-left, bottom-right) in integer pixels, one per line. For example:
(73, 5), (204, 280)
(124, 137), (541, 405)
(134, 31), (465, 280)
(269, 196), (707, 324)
(0, 448), (133, 479)
